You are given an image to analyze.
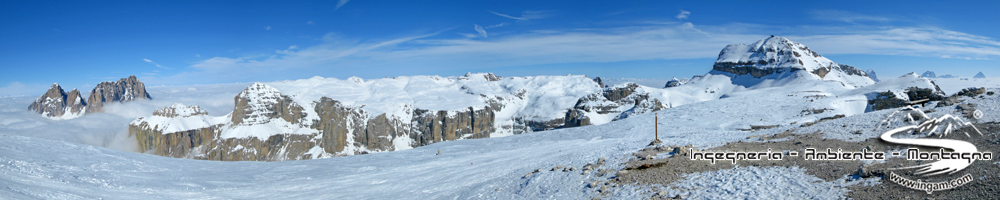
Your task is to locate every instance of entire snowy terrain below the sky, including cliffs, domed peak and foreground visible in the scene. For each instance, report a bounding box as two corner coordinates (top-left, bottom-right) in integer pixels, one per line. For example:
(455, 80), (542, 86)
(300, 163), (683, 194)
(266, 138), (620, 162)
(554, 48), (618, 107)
(0, 37), (1000, 199)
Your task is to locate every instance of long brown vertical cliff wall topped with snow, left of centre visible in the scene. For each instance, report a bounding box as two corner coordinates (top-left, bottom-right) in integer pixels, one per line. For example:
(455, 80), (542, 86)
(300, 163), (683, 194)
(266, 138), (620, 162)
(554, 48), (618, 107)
(129, 83), (498, 161)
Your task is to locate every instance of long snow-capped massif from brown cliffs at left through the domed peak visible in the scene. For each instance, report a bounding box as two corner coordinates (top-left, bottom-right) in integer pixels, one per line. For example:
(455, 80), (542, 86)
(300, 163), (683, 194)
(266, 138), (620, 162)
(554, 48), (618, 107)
(129, 37), (941, 161)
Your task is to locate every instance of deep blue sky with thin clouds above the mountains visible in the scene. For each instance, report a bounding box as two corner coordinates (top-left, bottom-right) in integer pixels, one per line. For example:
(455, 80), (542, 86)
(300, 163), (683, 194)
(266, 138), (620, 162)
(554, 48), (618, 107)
(0, 0), (1000, 96)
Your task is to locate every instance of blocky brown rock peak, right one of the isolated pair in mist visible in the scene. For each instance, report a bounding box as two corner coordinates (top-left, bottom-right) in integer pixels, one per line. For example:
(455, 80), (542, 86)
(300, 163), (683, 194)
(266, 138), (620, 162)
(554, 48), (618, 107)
(87, 76), (153, 113)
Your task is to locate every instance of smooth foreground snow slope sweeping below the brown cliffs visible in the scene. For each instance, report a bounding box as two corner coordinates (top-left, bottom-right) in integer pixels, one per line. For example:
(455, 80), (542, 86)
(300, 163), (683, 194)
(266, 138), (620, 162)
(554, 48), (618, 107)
(0, 83), (884, 199)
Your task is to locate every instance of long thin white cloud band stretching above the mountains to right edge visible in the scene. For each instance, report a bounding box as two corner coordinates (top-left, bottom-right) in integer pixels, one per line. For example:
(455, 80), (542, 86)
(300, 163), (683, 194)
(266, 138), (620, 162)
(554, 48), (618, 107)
(170, 22), (1000, 84)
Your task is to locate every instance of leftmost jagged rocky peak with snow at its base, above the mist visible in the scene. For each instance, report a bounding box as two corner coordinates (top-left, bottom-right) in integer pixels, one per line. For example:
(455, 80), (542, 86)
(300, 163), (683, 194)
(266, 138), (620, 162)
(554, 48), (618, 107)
(28, 84), (87, 119)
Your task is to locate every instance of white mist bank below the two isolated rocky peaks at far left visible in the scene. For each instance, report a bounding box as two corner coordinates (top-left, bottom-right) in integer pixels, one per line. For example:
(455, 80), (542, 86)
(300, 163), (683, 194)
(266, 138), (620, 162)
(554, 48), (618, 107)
(0, 83), (249, 152)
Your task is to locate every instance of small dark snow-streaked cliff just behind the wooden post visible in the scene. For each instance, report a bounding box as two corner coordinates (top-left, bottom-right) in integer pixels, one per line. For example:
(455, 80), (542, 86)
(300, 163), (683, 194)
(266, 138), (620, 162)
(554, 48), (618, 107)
(565, 83), (665, 128)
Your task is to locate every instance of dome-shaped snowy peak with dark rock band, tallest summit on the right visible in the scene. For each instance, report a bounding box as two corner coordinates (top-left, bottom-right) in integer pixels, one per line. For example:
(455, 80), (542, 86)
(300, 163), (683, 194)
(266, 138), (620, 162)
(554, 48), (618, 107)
(709, 36), (875, 88)
